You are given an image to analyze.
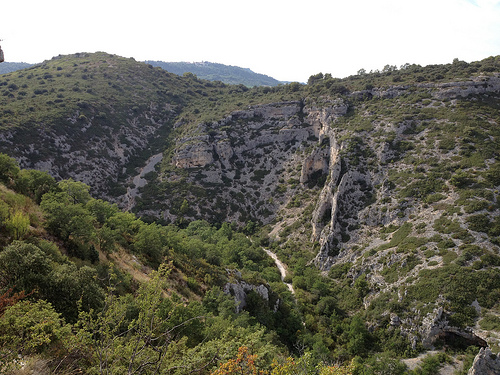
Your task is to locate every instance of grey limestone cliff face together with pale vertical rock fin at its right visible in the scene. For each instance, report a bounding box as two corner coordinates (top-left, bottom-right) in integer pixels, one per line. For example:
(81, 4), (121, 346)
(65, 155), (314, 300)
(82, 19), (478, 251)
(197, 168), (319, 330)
(159, 99), (360, 229)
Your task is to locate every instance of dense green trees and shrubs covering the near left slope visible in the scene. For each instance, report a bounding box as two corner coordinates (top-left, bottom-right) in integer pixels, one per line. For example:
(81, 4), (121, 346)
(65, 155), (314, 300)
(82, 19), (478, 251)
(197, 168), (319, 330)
(0, 155), (378, 373)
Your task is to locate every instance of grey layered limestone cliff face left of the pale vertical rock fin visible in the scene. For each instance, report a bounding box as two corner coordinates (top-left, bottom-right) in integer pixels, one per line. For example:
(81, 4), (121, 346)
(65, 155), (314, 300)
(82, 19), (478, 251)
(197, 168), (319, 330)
(154, 101), (316, 223)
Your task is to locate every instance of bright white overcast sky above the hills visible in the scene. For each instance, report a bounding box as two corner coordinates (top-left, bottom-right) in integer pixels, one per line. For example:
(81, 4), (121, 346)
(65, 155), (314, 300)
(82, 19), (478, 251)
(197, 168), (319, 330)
(0, 0), (500, 82)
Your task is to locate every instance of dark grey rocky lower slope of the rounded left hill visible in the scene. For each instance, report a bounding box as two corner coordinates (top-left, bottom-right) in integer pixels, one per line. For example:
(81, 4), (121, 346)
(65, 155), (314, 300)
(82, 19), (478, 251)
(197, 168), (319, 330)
(0, 103), (175, 196)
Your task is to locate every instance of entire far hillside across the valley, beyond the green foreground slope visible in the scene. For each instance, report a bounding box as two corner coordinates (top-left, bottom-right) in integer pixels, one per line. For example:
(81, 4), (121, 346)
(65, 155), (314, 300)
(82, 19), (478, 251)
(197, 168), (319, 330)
(0, 53), (500, 374)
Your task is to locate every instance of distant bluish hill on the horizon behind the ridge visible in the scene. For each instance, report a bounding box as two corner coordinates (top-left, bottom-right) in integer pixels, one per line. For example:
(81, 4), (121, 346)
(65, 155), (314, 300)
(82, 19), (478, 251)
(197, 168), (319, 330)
(145, 61), (283, 87)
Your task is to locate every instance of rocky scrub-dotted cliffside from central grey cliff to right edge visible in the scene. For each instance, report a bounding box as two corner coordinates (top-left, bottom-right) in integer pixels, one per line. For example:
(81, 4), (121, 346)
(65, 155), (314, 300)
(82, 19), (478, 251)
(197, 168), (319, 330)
(128, 75), (500, 354)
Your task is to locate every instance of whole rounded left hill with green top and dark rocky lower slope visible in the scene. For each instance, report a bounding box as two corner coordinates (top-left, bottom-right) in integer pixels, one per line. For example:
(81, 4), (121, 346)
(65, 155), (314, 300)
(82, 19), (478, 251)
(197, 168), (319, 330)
(0, 53), (236, 198)
